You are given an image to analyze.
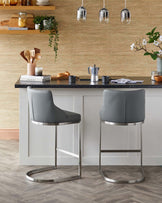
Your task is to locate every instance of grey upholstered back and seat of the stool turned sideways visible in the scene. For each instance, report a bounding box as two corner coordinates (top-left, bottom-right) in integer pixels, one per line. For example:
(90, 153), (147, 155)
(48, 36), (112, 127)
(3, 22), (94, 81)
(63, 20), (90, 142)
(27, 87), (81, 123)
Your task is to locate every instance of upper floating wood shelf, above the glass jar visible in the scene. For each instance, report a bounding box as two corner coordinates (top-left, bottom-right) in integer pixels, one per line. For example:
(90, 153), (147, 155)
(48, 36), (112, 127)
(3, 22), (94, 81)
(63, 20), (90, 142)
(0, 6), (56, 11)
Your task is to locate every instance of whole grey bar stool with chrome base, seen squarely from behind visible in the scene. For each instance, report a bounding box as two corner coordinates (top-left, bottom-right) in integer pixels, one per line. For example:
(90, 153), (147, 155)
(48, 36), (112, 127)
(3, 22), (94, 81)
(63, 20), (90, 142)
(99, 89), (145, 183)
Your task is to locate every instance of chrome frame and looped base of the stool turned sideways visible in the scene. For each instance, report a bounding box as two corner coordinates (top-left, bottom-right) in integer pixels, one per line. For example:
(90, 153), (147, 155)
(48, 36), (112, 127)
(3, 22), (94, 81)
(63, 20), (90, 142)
(26, 121), (82, 183)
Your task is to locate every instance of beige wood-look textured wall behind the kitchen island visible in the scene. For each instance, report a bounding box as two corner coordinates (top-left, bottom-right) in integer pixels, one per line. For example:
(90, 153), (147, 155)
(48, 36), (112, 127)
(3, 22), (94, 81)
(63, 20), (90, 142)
(0, 0), (162, 128)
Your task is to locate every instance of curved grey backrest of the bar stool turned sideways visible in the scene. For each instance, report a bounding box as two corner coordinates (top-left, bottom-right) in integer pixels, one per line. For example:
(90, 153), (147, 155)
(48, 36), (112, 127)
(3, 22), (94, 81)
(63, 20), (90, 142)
(27, 87), (55, 123)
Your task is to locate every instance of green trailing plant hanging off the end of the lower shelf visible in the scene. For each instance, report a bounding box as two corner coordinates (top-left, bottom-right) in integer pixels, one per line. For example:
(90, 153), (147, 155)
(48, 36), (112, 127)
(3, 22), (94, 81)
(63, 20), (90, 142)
(34, 16), (59, 60)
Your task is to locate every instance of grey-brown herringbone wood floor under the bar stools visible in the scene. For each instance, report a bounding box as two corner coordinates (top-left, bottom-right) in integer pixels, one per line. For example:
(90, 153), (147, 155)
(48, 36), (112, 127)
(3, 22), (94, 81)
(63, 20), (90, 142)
(0, 140), (162, 203)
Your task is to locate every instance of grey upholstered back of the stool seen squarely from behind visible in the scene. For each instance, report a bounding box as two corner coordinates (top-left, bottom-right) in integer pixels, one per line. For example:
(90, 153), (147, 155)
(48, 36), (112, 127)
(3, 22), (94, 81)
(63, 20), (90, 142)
(100, 89), (145, 123)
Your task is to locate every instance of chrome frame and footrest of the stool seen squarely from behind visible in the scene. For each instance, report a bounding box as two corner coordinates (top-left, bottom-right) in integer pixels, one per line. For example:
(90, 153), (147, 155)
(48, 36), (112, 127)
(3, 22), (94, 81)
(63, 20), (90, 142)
(99, 121), (145, 184)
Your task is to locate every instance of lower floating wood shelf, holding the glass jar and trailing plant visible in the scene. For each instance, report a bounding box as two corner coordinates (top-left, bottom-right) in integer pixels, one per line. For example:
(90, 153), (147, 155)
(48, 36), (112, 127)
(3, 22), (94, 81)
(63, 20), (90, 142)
(0, 30), (49, 35)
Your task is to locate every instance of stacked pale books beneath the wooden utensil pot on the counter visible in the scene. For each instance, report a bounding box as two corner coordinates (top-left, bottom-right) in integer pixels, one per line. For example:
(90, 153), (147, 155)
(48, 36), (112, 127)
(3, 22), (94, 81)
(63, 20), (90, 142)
(20, 75), (51, 82)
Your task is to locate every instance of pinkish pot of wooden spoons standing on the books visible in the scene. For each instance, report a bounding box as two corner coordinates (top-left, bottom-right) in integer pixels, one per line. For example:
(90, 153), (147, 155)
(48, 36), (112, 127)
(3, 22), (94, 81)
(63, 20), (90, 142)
(20, 48), (41, 75)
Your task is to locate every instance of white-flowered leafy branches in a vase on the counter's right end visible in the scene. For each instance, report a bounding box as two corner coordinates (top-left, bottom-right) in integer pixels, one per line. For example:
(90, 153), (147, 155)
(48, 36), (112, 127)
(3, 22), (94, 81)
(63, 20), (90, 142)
(131, 27), (162, 75)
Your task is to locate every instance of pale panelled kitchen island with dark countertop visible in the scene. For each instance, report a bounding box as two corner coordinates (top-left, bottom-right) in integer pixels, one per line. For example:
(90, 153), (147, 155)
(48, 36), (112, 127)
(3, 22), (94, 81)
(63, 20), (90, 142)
(15, 76), (162, 165)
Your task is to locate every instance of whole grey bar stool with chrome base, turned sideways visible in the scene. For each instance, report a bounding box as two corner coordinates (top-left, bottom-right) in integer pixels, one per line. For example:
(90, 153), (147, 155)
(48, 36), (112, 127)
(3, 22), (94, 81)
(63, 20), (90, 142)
(26, 87), (81, 183)
